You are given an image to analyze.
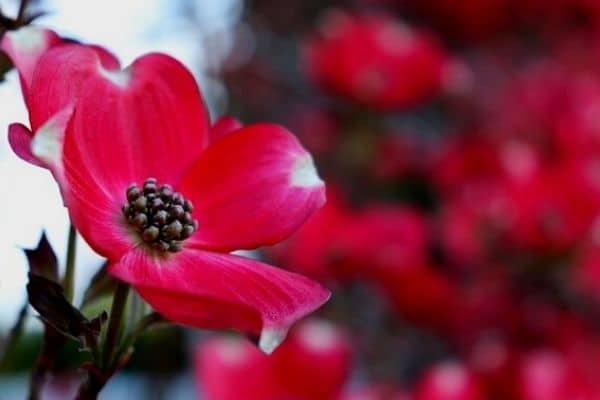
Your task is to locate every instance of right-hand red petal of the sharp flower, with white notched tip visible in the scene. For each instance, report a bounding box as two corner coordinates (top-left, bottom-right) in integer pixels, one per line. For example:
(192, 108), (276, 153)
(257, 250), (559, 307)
(179, 124), (325, 251)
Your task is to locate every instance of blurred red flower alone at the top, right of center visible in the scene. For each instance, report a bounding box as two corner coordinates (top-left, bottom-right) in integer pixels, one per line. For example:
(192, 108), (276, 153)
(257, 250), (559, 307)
(302, 10), (458, 111)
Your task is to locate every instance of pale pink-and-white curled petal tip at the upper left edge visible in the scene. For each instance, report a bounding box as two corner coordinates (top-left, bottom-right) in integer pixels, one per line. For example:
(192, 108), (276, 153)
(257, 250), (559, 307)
(0, 25), (62, 103)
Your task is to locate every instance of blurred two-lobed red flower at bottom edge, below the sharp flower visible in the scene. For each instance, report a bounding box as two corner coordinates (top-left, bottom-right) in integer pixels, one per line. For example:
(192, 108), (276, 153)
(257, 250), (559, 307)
(195, 319), (352, 400)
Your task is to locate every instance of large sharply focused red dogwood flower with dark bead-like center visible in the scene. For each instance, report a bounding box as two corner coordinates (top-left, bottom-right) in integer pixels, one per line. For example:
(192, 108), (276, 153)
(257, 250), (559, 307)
(19, 45), (329, 352)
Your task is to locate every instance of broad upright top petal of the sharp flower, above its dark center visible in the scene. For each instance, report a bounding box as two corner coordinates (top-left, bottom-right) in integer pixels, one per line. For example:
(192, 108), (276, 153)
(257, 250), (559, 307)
(61, 49), (208, 191)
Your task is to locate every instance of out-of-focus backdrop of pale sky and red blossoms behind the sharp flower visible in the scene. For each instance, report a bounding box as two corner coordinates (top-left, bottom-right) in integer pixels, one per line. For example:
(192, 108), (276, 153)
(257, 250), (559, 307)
(5, 0), (600, 400)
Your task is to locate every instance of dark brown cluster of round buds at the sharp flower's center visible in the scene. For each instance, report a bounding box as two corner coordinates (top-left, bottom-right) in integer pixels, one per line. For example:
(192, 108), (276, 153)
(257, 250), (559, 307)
(123, 178), (198, 252)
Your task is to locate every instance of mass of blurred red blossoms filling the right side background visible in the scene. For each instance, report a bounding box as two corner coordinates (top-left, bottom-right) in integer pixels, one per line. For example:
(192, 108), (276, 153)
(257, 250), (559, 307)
(212, 0), (600, 400)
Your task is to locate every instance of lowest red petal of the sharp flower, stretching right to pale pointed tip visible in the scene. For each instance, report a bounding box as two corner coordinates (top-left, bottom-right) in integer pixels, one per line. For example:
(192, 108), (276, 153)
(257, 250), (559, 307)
(109, 248), (330, 353)
